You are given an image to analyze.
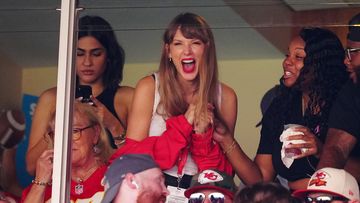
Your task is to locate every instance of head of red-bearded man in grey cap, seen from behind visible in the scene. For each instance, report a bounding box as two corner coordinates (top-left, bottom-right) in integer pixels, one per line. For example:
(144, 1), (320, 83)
(102, 154), (169, 203)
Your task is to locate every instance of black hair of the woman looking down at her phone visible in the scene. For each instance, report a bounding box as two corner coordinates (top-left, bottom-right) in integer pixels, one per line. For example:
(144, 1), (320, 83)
(78, 15), (125, 89)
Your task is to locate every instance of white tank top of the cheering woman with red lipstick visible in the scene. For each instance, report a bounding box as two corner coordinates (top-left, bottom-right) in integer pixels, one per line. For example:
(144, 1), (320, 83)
(149, 72), (221, 177)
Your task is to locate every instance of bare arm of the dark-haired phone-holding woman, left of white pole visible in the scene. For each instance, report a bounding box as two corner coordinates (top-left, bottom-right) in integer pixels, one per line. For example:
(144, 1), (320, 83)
(26, 88), (56, 175)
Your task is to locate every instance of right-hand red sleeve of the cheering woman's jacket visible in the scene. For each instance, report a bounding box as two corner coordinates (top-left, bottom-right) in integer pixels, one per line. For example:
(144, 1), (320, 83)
(190, 128), (233, 175)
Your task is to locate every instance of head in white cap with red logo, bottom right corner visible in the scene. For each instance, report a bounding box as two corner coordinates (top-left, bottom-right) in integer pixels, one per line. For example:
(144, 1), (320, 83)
(293, 168), (359, 203)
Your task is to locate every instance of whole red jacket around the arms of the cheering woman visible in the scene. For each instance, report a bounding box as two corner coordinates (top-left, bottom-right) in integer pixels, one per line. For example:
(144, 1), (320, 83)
(110, 115), (233, 175)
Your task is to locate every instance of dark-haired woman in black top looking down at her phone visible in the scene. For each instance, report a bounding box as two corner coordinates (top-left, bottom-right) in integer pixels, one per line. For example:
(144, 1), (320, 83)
(26, 16), (133, 174)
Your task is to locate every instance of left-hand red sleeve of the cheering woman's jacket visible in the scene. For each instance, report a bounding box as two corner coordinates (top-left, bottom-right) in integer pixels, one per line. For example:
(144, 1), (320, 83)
(110, 115), (193, 170)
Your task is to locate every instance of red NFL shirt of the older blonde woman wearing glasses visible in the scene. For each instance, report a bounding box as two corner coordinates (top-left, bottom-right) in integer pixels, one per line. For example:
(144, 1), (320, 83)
(21, 165), (107, 202)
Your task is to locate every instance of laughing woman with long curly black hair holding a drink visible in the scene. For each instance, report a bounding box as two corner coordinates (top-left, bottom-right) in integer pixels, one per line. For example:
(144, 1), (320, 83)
(255, 28), (348, 190)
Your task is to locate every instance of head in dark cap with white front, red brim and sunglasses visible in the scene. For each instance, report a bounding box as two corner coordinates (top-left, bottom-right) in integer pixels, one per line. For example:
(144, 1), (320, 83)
(185, 169), (237, 203)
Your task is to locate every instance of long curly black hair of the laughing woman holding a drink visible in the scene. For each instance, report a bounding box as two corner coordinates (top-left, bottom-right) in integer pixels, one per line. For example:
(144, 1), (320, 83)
(295, 28), (349, 141)
